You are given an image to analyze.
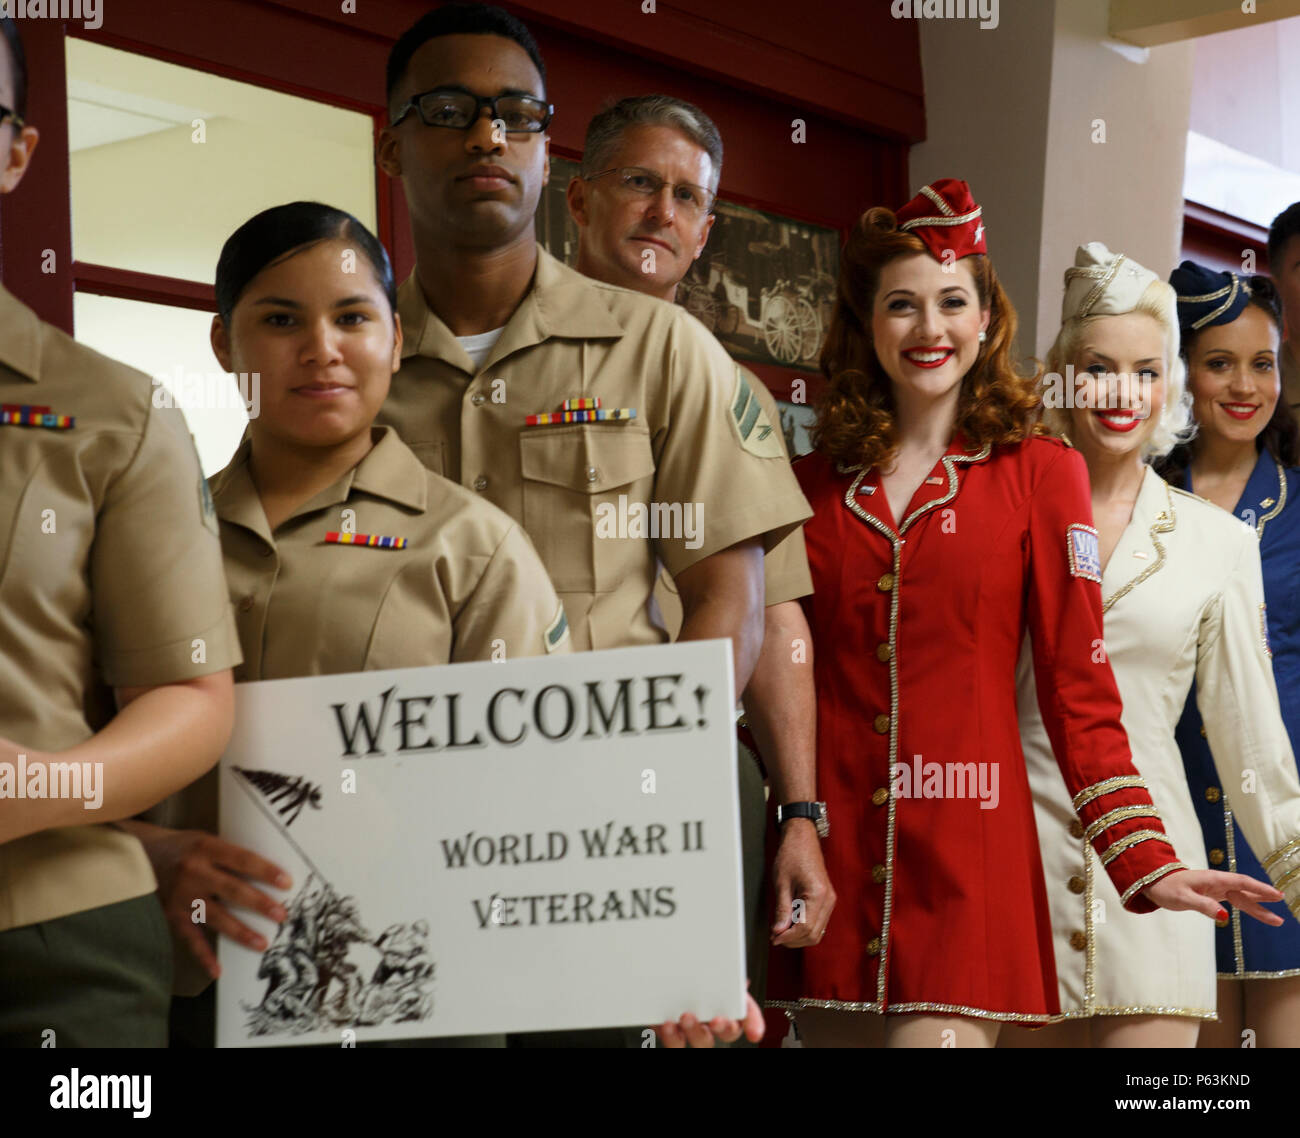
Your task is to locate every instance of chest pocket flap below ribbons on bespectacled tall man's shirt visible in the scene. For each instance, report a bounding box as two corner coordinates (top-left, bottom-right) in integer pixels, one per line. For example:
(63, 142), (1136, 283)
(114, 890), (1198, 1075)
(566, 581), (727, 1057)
(519, 424), (655, 494)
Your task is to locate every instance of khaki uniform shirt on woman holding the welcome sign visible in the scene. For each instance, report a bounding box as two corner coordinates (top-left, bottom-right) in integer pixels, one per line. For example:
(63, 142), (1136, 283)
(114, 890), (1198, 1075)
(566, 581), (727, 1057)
(157, 428), (571, 995)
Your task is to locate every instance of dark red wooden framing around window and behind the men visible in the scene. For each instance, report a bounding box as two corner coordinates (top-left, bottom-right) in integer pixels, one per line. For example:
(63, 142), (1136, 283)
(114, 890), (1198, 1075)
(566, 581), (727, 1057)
(0, 0), (924, 397)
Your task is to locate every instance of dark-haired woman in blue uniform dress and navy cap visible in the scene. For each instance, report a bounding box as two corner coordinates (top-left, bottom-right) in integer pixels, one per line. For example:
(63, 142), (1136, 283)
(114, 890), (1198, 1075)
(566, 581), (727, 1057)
(1161, 261), (1300, 1047)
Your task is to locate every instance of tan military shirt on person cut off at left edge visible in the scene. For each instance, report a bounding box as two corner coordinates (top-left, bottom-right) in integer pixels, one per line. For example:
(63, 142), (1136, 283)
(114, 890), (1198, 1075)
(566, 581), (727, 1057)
(0, 280), (239, 930)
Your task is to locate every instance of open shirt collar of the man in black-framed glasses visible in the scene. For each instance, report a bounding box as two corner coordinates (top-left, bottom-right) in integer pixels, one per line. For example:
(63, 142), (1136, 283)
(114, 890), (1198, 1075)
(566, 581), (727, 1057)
(398, 246), (624, 375)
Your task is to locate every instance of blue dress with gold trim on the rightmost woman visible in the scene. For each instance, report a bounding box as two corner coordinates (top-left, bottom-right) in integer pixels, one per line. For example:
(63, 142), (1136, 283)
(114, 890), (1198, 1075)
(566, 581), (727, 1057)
(1175, 451), (1300, 979)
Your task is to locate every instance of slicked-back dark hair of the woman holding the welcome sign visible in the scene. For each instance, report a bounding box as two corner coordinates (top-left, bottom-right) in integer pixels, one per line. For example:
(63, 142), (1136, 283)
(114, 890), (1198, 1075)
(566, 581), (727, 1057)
(216, 202), (398, 324)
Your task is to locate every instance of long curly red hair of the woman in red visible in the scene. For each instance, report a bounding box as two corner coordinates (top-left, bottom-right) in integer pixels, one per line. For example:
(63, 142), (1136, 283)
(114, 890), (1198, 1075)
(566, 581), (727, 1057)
(813, 207), (1040, 468)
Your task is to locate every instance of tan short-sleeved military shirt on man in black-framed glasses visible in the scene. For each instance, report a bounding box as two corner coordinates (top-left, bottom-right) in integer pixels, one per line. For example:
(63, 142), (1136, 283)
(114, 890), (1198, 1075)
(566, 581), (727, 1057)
(380, 250), (811, 649)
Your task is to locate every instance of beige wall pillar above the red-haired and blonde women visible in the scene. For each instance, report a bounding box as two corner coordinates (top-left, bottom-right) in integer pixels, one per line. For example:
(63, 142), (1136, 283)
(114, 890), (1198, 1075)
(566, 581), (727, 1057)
(911, 0), (1192, 356)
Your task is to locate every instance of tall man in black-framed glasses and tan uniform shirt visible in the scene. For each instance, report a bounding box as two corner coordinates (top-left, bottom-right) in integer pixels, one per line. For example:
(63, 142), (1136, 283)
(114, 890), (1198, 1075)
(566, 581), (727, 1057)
(378, 4), (811, 1046)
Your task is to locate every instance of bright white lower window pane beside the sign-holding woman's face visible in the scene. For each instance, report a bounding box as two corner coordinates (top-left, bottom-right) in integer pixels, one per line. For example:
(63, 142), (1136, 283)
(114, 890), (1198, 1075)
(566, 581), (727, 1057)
(73, 293), (248, 475)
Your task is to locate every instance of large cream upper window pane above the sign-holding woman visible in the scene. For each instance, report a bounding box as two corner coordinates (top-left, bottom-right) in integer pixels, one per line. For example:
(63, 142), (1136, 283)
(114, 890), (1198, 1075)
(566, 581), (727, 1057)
(66, 36), (376, 284)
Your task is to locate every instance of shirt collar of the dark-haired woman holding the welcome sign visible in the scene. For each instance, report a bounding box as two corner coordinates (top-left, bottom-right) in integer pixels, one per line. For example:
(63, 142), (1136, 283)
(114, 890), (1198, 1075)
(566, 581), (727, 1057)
(212, 427), (429, 544)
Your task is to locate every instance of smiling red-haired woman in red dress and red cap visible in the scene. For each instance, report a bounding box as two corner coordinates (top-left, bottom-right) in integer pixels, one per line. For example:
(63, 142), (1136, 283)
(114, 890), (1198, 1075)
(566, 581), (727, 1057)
(770, 179), (1279, 1046)
